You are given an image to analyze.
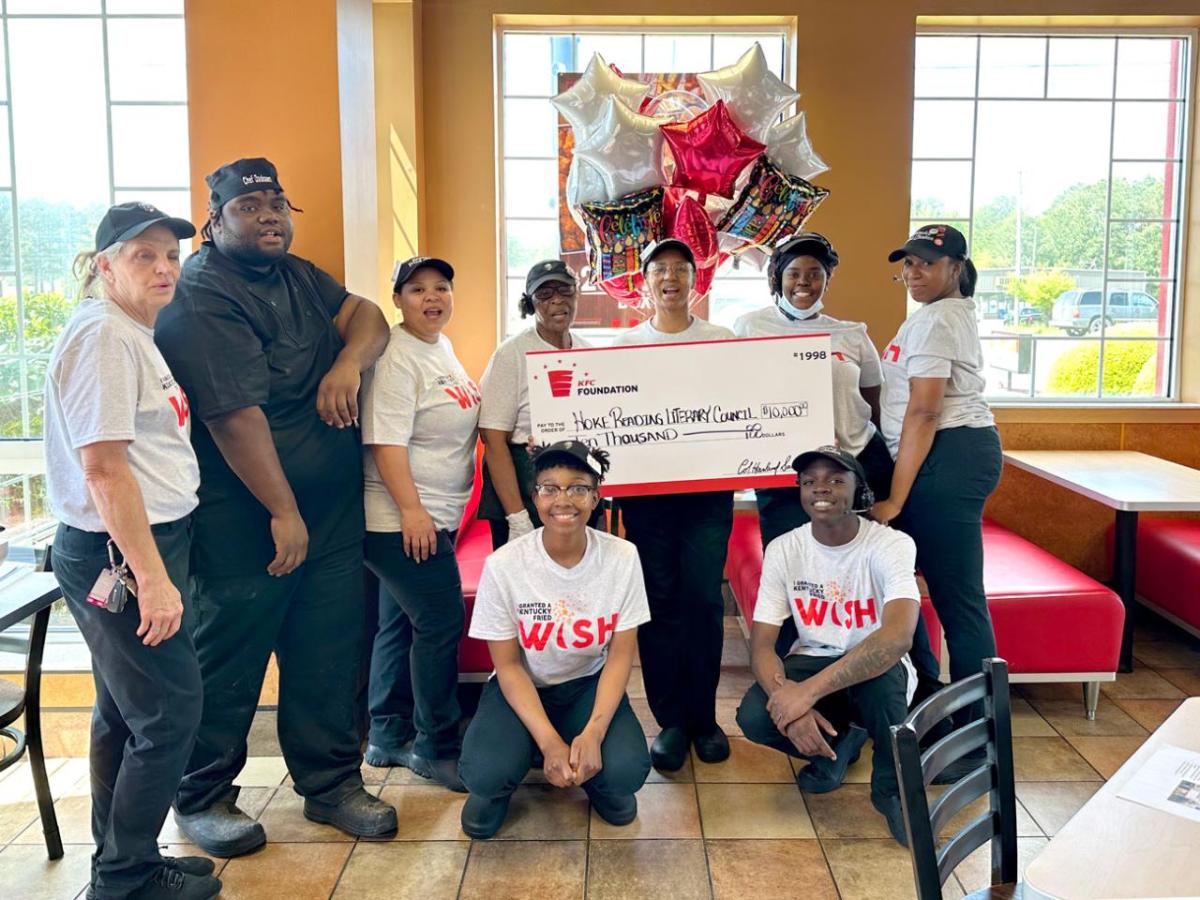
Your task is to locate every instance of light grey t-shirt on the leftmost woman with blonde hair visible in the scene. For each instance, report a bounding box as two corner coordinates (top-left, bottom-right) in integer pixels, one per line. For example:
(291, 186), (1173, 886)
(44, 298), (200, 532)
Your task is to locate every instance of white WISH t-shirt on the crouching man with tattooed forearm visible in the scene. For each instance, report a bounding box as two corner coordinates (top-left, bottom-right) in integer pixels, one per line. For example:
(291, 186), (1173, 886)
(754, 518), (920, 701)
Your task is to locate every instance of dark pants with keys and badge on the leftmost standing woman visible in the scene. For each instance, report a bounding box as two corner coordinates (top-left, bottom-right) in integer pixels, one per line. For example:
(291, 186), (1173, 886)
(53, 518), (202, 900)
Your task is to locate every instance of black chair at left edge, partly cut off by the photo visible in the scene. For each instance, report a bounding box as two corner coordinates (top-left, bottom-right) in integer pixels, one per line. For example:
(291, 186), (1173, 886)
(0, 548), (62, 859)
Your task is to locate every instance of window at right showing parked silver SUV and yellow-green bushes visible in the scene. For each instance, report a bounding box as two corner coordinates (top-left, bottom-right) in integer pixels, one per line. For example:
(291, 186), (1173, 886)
(911, 32), (1192, 402)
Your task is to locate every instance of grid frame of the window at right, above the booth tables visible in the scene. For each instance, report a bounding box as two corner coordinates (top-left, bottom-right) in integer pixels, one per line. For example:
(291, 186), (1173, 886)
(908, 23), (1200, 410)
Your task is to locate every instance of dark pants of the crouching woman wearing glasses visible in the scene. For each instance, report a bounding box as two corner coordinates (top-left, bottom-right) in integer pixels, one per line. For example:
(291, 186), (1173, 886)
(458, 673), (650, 800)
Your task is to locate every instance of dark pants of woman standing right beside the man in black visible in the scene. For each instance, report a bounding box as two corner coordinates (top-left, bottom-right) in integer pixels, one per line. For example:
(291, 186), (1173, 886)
(364, 532), (463, 760)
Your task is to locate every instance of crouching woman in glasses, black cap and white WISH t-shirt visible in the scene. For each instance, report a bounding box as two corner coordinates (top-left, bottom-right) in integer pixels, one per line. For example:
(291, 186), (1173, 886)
(460, 440), (650, 839)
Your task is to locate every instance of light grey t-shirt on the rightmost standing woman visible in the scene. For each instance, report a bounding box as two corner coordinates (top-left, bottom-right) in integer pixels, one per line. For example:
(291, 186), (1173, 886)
(880, 298), (995, 457)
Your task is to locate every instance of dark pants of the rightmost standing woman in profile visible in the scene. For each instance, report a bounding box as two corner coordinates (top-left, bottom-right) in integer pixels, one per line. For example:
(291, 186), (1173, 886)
(892, 427), (1003, 718)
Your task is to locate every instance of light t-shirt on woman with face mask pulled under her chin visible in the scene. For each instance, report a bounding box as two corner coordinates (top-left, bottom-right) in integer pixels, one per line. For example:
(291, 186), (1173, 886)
(733, 304), (883, 456)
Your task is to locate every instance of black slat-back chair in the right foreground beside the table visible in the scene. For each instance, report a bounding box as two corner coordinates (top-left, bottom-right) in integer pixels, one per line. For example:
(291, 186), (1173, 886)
(892, 659), (1021, 900)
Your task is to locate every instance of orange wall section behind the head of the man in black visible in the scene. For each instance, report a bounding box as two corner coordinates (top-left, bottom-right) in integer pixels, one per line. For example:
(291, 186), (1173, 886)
(184, 0), (345, 278)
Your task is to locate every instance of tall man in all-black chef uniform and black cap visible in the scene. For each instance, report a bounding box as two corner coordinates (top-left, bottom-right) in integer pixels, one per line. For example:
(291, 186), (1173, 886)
(155, 158), (396, 857)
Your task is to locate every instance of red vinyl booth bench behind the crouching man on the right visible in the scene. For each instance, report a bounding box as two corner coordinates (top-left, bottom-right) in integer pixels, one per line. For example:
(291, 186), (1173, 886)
(728, 510), (1123, 674)
